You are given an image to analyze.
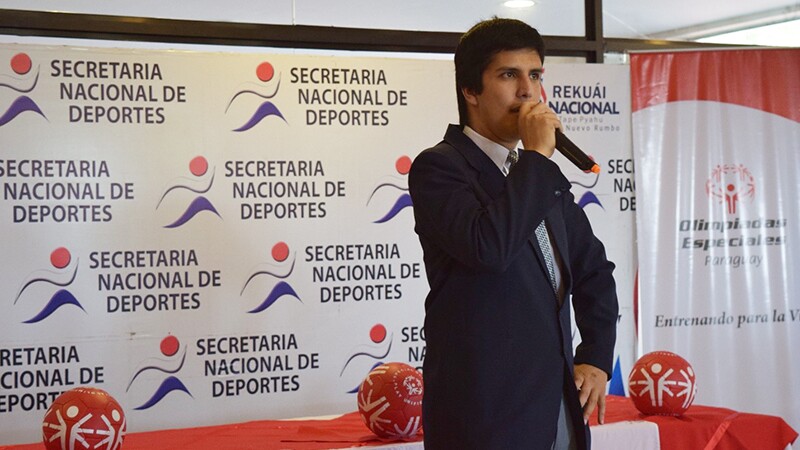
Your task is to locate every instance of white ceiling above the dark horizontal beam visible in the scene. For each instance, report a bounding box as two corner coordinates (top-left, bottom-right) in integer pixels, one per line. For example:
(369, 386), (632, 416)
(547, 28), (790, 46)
(0, 0), (800, 39)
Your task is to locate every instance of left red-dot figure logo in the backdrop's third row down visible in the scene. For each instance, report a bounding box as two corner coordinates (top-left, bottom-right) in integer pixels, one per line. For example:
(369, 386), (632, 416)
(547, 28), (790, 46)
(14, 247), (86, 324)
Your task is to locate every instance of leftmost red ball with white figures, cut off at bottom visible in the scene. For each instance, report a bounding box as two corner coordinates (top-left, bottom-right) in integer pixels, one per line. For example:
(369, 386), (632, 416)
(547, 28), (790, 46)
(42, 387), (126, 450)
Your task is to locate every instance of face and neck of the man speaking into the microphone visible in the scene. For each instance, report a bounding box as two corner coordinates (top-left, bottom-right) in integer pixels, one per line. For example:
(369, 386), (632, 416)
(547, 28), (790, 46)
(463, 49), (543, 148)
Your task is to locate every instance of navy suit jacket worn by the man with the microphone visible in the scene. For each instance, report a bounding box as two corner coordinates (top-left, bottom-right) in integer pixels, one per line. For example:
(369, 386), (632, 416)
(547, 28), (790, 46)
(409, 125), (618, 450)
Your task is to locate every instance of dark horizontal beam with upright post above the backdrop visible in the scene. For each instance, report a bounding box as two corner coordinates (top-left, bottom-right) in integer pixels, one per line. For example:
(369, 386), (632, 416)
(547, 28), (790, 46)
(0, 4), (736, 63)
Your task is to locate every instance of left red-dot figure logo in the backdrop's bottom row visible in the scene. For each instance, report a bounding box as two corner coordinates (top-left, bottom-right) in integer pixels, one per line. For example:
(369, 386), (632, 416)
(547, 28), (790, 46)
(125, 335), (192, 411)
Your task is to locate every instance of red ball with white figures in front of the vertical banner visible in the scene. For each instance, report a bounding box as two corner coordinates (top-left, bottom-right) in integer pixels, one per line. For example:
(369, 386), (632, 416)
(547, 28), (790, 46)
(628, 351), (697, 416)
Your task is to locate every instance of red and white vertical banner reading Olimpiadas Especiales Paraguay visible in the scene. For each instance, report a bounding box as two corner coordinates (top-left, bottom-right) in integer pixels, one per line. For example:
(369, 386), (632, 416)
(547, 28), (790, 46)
(631, 49), (800, 428)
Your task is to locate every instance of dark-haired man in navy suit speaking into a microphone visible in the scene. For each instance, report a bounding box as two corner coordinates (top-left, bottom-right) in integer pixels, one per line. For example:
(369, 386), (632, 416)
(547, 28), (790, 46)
(409, 18), (618, 450)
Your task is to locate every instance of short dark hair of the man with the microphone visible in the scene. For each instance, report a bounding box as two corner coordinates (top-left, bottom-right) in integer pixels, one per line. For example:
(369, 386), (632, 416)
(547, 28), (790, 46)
(455, 17), (544, 125)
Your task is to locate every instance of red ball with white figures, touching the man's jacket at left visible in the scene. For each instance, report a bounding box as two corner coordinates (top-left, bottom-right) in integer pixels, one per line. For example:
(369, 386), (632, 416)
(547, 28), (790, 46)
(358, 362), (423, 439)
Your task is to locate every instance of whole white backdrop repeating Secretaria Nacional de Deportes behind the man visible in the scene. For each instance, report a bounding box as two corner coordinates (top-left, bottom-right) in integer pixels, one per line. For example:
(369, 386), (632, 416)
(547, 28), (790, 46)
(0, 45), (634, 443)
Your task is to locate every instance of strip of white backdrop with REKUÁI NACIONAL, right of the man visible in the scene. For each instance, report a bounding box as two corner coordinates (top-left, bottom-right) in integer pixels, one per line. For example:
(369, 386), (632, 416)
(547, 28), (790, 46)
(542, 64), (637, 395)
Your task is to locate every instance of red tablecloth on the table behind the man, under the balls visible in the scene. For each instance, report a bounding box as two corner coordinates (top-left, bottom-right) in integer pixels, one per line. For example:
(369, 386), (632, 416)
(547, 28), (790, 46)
(0, 396), (797, 450)
